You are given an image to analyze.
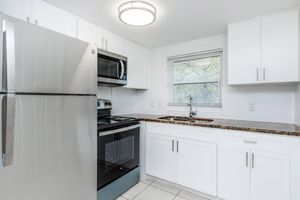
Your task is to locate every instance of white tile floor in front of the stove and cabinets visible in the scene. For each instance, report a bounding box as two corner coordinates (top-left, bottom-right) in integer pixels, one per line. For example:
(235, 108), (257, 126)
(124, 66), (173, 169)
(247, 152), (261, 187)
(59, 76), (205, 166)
(117, 179), (209, 200)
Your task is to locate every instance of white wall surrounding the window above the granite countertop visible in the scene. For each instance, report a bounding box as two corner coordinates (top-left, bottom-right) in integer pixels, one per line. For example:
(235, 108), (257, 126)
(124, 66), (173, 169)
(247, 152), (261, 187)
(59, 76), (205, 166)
(136, 35), (300, 123)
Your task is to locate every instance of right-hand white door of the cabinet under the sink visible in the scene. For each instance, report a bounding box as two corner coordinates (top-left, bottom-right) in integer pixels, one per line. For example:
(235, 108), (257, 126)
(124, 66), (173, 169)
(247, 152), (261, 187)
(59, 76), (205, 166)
(176, 139), (217, 196)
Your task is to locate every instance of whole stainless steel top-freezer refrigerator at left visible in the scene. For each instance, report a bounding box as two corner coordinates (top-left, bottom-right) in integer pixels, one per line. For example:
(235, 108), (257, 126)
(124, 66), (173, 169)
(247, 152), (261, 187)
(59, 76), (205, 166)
(0, 13), (97, 200)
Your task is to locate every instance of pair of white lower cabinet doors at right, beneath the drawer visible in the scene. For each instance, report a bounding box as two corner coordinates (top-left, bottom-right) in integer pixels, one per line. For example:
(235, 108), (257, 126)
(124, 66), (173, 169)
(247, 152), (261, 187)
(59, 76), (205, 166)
(218, 141), (290, 200)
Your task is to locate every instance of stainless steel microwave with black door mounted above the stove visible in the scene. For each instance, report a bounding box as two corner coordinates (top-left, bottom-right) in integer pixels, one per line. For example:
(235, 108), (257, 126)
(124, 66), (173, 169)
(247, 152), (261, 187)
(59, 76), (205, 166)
(98, 49), (127, 86)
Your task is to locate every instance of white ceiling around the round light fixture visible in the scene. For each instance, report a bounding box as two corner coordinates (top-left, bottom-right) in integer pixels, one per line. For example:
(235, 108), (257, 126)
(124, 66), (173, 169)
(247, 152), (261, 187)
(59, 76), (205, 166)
(45, 0), (300, 48)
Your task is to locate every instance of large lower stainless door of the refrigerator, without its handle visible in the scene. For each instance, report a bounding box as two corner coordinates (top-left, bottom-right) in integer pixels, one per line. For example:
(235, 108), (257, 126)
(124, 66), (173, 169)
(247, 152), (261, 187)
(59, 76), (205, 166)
(0, 95), (97, 200)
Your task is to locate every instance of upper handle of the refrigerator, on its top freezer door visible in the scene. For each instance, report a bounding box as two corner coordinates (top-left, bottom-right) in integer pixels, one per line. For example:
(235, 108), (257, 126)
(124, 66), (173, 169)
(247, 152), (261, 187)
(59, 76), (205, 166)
(2, 19), (16, 92)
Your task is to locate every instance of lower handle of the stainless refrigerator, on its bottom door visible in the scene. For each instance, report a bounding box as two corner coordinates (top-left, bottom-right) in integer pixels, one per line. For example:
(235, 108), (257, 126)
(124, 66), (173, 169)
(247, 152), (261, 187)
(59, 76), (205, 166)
(1, 94), (16, 167)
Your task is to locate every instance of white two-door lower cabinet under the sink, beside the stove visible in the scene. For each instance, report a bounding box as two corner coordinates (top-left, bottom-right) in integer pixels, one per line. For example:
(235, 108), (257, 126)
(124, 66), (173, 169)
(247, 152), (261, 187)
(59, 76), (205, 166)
(145, 122), (217, 196)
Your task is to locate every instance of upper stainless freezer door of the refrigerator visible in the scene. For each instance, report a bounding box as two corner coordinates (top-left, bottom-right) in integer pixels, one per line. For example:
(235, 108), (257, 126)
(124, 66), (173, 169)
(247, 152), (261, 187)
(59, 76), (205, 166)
(2, 16), (97, 94)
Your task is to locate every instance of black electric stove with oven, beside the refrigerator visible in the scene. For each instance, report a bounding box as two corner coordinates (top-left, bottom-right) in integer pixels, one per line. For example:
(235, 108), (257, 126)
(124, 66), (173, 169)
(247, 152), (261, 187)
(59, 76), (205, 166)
(97, 99), (140, 196)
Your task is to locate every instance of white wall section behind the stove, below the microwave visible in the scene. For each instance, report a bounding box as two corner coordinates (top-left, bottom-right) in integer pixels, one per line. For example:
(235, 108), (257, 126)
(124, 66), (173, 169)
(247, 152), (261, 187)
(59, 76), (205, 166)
(97, 86), (138, 115)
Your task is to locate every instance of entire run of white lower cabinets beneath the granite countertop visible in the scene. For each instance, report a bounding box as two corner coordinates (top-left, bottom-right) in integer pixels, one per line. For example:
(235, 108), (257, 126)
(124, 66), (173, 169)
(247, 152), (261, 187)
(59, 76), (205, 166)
(145, 122), (292, 200)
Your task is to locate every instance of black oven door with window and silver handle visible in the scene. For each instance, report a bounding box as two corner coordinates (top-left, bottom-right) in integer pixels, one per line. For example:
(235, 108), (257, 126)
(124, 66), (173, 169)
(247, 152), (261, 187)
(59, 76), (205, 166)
(98, 124), (140, 190)
